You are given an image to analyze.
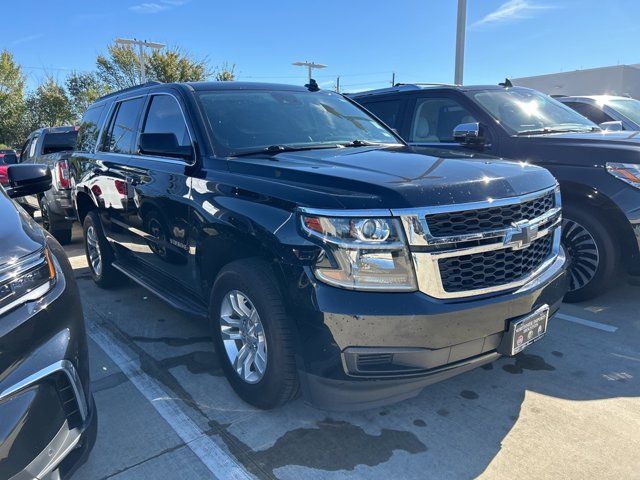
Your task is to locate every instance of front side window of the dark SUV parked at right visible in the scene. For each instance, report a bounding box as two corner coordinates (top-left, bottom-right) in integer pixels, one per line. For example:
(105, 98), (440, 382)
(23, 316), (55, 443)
(409, 98), (477, 143)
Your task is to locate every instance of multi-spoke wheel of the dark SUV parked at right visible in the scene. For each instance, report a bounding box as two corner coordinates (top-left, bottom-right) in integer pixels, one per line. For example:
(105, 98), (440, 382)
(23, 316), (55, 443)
(562, 218), (600, 292)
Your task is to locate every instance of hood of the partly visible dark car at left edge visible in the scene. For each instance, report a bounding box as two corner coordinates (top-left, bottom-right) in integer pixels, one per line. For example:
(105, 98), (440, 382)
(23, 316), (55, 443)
(0, 189), (45, 267)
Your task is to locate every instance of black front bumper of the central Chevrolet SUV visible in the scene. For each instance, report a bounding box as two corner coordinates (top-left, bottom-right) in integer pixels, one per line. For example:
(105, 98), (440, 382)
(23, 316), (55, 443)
(288, 249), (567, 410)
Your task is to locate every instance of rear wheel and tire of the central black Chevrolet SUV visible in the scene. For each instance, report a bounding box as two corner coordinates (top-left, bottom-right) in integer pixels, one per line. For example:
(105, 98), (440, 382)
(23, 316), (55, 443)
(82, 210), (122, 288)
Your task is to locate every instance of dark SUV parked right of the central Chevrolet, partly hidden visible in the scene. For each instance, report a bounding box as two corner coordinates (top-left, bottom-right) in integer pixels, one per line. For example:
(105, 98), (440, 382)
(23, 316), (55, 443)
(351, 84), (640, 301)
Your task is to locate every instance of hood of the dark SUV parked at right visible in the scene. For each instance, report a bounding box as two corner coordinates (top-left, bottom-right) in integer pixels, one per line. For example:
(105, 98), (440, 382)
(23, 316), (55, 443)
(516, 131), (640, 166)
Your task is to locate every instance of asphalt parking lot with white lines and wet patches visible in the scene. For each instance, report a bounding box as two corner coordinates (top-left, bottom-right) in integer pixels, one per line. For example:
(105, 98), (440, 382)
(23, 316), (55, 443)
(60, 229), (640, 480)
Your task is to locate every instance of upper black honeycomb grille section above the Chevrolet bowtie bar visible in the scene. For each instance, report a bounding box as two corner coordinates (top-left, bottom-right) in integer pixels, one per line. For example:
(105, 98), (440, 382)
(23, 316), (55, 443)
(427, 192), (555, 237)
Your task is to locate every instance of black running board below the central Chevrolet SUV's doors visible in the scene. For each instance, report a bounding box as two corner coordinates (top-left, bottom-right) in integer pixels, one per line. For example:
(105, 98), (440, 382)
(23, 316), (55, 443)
(112, 259), (208, 318)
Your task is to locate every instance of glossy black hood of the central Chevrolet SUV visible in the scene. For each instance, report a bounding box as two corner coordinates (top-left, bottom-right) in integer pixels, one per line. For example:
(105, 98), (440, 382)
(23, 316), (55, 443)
(229, 147), (556, 209)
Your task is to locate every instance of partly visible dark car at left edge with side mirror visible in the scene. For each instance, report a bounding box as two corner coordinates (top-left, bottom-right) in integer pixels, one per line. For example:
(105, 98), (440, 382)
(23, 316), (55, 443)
(0, 165), (97, 480)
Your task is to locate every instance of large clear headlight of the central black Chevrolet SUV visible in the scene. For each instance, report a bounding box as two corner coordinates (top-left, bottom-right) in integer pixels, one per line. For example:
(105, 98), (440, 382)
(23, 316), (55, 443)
(301, 214), (417, 292)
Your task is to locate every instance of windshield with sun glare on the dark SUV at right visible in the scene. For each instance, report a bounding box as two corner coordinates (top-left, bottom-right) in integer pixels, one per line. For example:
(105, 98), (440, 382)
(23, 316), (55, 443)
(469, 88), (598, 133)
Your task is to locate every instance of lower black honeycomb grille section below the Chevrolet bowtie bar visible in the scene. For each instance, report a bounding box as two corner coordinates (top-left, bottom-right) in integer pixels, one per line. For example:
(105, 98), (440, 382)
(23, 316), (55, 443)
(438, 235), (553, 292)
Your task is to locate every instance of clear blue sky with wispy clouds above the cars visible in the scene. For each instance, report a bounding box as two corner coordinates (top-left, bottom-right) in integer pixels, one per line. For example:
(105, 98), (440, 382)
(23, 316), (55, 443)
(5, 0), (640, 91)
